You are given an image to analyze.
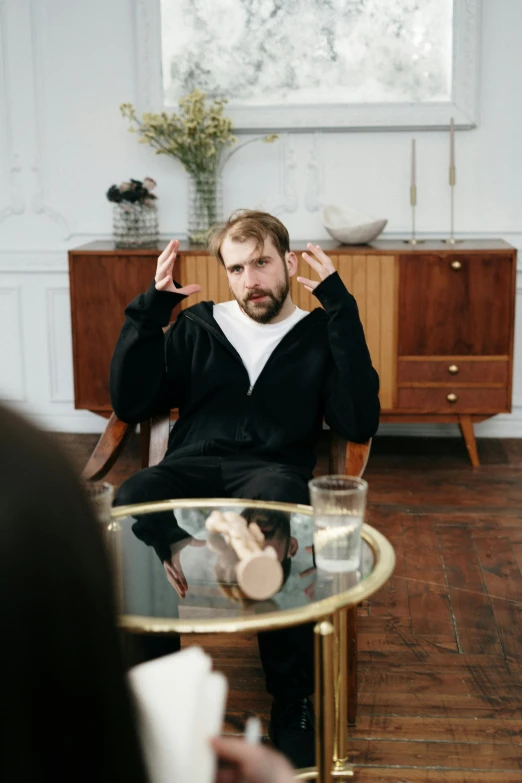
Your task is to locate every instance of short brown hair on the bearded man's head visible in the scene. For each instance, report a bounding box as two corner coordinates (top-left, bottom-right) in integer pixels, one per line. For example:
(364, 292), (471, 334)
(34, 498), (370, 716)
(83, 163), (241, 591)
(208, 209), (290, 266)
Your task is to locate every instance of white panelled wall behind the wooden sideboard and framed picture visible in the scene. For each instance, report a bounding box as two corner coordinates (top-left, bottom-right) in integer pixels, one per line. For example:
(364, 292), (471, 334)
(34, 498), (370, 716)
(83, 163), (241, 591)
(0, 0), (522, 437)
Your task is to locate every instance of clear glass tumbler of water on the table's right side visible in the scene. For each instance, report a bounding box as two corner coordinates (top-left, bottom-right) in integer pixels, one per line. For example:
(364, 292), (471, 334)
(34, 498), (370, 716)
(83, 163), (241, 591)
(308, 476), (368, 573)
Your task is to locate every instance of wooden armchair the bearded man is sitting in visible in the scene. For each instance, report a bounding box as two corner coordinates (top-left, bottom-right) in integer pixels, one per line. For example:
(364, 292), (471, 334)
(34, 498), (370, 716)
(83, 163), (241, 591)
(82, 413), (371, 726)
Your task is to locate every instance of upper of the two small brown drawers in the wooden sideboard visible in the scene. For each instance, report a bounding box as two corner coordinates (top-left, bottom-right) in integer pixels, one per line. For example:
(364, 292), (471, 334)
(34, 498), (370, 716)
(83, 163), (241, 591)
(397, 357), (509, 385)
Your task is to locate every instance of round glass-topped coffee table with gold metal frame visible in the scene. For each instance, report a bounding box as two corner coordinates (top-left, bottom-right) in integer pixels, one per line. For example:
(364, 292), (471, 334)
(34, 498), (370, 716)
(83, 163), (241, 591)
(106, 498), (395, 783)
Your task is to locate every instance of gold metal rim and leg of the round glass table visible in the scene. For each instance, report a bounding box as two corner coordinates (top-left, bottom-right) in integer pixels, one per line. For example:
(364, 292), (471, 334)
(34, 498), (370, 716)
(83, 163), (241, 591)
(108, 498), (395, 783)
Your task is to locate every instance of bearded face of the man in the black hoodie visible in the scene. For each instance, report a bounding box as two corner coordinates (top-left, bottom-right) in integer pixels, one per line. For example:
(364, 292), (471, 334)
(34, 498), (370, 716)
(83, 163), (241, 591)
(221, 237), (290, 324)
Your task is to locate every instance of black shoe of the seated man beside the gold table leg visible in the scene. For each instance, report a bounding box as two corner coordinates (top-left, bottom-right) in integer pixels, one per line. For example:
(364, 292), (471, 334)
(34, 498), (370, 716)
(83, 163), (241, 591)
(268, 698), (315, 769)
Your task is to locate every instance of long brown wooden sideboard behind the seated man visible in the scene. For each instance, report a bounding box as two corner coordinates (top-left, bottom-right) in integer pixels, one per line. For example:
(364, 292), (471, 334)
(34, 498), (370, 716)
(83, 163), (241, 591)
(69, 240), (516, 465)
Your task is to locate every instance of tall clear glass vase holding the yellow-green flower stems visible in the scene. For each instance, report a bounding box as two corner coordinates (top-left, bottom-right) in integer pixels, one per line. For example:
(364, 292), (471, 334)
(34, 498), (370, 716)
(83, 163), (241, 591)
(187, 171), (223, 245)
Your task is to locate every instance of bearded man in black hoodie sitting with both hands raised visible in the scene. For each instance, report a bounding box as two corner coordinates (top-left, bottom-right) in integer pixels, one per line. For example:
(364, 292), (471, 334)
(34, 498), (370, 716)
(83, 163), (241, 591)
(110, 210), (379, 767)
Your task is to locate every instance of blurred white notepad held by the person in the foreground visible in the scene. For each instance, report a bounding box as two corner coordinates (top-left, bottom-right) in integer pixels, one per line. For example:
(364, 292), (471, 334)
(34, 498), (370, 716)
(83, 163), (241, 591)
(128, 647), (227, 783)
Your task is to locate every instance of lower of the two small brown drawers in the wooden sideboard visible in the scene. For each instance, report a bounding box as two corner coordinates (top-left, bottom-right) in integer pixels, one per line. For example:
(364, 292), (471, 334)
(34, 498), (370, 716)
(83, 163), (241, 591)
(397, 385), (508, 413)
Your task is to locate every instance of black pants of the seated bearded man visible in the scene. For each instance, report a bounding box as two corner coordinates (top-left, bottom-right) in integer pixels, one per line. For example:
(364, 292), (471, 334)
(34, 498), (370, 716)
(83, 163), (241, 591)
(114, 455), (314, 699)
